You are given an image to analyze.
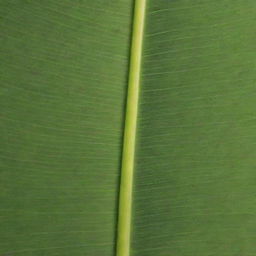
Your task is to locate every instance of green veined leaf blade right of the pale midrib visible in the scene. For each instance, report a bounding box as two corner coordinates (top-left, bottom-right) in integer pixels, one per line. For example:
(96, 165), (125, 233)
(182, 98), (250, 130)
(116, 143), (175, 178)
(132, 0), (256, 256)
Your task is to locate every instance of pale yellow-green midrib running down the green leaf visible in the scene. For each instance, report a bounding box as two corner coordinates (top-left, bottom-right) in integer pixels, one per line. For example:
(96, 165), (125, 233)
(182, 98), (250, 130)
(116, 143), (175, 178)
(116, 0), (146, 256)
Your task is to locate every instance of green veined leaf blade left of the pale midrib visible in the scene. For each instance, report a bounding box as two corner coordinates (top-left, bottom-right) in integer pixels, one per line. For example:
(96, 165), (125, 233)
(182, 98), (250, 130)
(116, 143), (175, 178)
(0, 0), (132, 256)
